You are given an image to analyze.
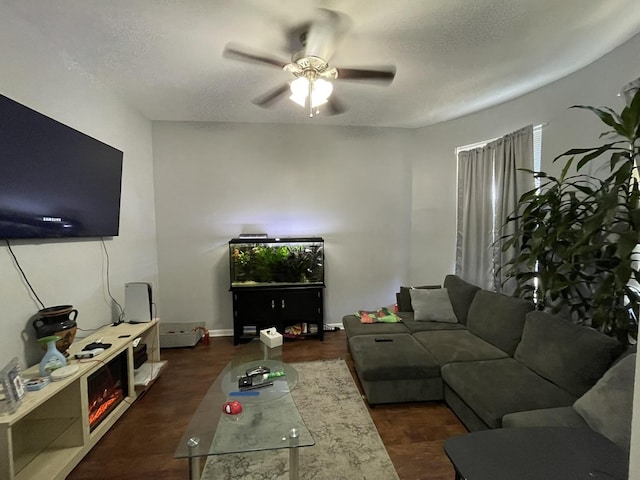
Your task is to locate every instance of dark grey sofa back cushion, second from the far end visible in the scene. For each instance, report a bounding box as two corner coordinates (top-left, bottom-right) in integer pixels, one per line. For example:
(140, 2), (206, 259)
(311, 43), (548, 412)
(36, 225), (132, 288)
(467, 290), (533, 356)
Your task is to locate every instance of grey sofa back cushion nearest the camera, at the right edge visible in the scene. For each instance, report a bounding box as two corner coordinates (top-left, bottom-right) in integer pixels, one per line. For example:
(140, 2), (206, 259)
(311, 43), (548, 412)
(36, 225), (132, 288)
(573, 353), (636, 452)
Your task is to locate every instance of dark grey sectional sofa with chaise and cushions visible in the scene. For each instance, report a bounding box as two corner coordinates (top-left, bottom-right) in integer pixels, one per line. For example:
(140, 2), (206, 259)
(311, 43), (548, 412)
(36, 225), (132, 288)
(343, 275), (635, 462)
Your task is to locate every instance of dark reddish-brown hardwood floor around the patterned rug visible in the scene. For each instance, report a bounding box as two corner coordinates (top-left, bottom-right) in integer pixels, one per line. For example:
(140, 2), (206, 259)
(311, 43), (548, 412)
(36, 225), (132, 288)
(67, 331), (466, 480)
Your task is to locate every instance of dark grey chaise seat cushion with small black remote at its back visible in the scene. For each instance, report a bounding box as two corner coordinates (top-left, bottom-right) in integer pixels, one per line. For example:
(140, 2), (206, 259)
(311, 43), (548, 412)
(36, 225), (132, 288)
(349, 333), (440, 381)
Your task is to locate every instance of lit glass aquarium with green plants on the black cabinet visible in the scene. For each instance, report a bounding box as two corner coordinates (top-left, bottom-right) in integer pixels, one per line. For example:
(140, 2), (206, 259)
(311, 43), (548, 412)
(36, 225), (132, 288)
(229, 237), (324, 288)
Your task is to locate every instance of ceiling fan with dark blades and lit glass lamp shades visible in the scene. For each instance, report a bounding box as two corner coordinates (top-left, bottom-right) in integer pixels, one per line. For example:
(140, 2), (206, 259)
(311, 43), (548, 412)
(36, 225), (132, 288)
(223, 8), (396, 117)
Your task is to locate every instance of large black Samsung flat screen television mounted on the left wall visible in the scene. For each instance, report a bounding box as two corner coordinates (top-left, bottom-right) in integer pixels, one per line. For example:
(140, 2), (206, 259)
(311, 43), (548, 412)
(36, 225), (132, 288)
(0, 95), (123, 239)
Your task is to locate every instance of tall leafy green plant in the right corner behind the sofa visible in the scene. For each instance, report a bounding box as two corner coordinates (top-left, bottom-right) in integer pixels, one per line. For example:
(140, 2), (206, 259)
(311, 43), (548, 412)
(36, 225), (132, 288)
(503, 91), (640, 342)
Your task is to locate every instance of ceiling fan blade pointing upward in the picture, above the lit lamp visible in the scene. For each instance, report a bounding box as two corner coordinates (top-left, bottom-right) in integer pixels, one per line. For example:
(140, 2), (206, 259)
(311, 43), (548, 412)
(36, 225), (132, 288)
(304, 8), (350, 62)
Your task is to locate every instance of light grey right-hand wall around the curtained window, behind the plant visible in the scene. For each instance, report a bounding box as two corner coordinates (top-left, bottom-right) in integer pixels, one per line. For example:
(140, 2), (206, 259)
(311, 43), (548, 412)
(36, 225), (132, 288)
(409, 35), (640, 284)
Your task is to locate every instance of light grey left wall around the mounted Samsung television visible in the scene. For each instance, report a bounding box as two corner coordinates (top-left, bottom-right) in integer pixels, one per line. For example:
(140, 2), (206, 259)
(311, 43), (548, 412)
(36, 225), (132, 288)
(0, 8), (157, 368)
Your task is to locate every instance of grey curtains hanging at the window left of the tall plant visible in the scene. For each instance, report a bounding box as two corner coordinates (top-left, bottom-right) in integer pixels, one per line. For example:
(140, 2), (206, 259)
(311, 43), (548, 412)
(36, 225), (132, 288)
(456, 125), (534, 294)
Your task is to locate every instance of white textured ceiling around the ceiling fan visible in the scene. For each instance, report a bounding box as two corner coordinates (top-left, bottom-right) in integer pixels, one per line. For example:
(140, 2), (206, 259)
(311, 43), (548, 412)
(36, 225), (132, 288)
(0, 0), (640, 127)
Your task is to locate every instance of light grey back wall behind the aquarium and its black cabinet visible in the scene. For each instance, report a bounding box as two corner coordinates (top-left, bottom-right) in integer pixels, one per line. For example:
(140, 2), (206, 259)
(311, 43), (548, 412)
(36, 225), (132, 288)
(153, 122), (411, 330)
